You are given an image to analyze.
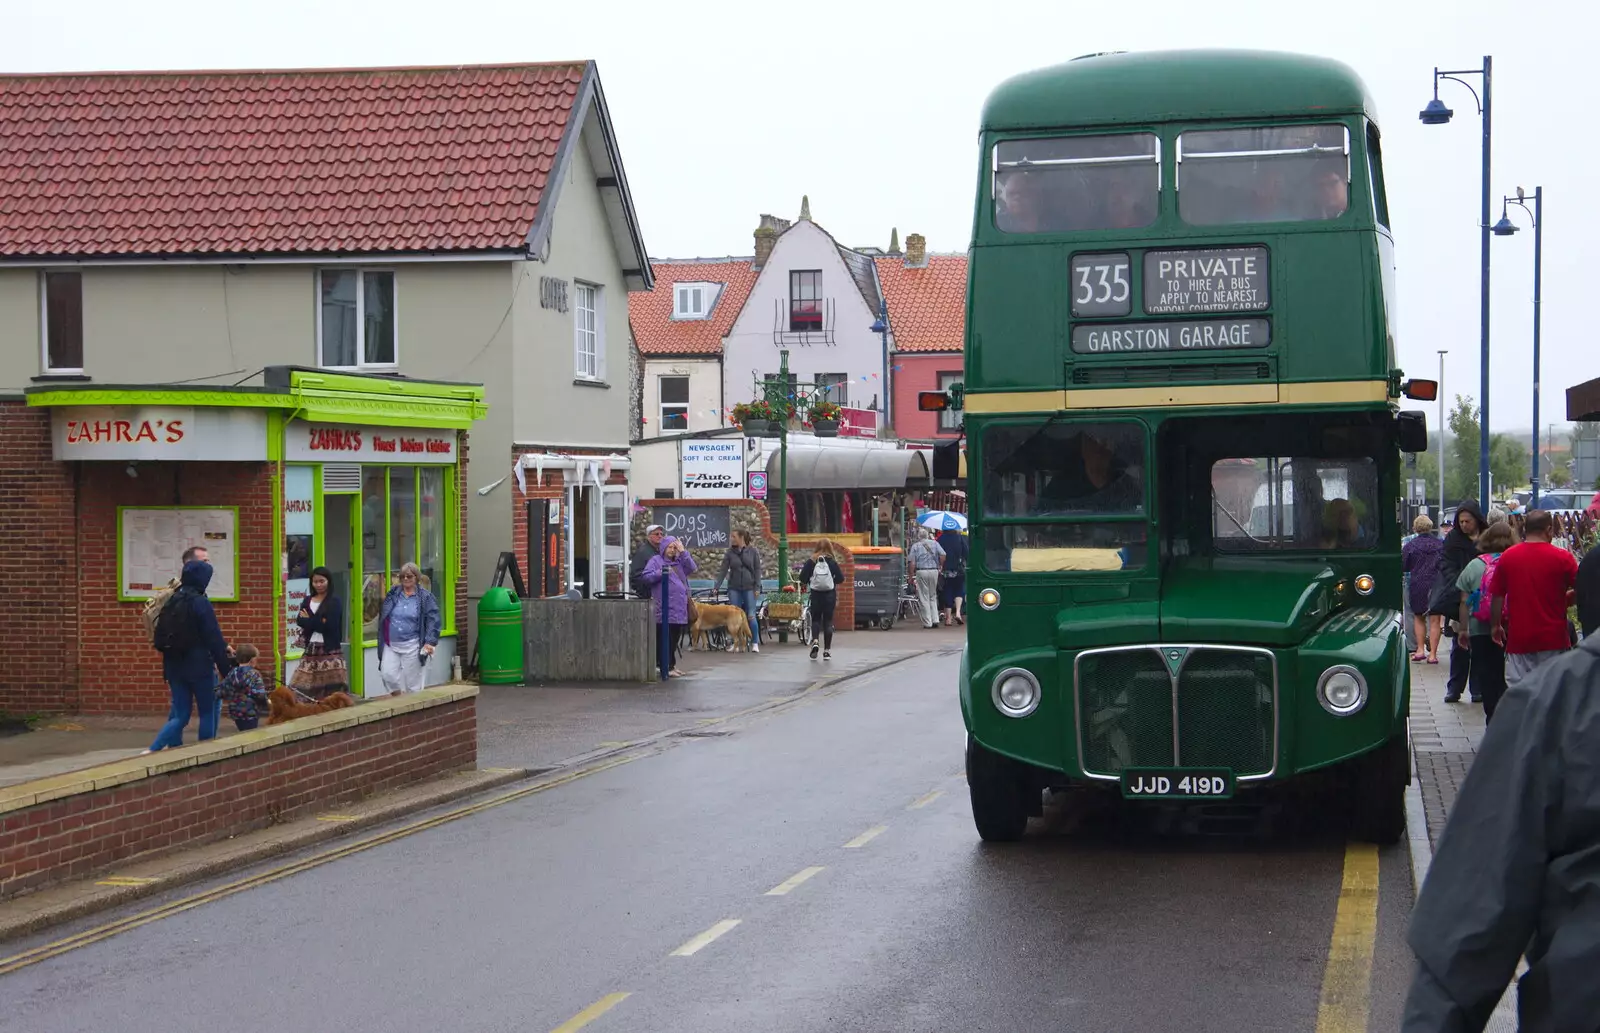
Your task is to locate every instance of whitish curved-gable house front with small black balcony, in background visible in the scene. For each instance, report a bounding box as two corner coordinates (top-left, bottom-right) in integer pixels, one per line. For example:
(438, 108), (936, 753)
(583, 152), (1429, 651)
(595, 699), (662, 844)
(723, 221), (883, 408)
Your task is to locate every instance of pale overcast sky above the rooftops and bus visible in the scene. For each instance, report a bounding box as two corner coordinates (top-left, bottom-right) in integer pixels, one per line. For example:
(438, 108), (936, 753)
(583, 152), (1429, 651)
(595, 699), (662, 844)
(9, 0), (1600, 429)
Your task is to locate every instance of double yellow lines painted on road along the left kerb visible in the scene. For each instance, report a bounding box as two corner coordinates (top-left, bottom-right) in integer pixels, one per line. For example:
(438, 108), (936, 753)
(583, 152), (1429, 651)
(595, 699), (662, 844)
(0, 753), (648, 975)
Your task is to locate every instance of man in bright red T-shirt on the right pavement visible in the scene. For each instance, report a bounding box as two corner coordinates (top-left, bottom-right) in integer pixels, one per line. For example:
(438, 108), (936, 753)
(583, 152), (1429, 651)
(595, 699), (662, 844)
(1490, 510), (1578, 684)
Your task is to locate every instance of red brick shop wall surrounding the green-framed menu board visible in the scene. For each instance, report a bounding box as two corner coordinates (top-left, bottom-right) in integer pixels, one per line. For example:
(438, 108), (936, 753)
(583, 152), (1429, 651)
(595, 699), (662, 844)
(76, 462), (282, 713)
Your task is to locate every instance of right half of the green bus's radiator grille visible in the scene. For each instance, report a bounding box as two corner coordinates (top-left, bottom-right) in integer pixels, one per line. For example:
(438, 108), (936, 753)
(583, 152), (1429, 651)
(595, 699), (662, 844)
(1178, 649), (1277, 776)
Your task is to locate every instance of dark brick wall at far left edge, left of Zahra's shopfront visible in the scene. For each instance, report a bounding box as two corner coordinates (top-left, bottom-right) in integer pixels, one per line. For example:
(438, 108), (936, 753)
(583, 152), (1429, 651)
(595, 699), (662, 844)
(0, 401), (78, 713)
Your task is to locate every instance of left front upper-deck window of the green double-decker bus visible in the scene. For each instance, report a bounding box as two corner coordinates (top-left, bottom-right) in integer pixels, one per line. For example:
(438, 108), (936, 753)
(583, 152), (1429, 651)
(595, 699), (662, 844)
(994, 133), (1162, 233)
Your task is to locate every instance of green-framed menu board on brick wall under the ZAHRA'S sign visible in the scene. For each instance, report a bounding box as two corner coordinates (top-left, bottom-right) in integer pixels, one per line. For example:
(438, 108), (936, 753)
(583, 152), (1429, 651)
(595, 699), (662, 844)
(117, 505), (238, 603)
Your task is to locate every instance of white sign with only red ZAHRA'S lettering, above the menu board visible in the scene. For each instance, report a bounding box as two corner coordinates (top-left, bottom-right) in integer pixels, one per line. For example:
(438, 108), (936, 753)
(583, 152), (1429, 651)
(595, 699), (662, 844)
(50, 405), (267, 462)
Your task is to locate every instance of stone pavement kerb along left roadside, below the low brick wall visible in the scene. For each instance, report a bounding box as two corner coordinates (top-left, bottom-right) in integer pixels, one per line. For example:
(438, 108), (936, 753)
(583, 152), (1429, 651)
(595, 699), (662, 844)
(0, 651), (928, 942)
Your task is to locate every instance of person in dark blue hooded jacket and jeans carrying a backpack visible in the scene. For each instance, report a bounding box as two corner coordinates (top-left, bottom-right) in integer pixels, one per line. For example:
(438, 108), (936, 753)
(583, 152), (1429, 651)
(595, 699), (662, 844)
(146, 560), (232, 753)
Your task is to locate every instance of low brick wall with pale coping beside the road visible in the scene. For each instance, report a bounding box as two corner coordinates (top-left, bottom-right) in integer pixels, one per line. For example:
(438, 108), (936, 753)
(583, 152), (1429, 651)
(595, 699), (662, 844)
(0, 684), (478, 900)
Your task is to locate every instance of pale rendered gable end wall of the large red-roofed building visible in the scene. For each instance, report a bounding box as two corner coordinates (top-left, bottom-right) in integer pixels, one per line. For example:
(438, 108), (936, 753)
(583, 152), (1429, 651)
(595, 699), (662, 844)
(514, 130), (633, 449)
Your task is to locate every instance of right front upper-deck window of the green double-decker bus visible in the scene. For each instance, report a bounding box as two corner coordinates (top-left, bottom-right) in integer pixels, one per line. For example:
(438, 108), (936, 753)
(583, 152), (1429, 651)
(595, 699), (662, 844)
(1178, 125), (1350, 225)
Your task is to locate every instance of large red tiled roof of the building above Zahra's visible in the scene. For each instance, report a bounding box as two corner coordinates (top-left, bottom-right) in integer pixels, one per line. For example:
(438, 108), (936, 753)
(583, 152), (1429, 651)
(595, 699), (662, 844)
(0, 62), (592, 256)
